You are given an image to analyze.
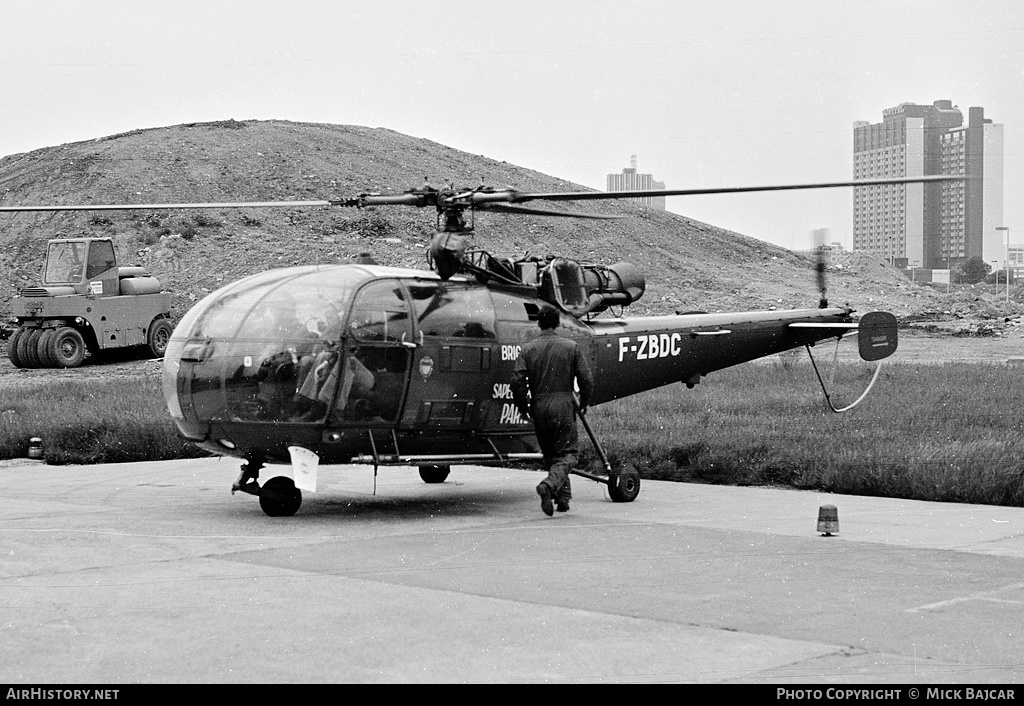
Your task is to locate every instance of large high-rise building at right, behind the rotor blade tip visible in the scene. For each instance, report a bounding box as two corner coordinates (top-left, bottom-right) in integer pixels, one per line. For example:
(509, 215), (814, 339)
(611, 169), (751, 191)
(853, 100), (1007, 268)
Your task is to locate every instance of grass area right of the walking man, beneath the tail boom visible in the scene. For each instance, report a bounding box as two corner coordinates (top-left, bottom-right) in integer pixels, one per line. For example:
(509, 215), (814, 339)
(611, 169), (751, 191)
(581, 362), (1024, 505)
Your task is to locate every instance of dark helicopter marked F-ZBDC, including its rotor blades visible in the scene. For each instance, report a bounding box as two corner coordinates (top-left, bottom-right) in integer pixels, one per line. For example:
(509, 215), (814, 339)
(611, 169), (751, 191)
(0, 170), (964, 516)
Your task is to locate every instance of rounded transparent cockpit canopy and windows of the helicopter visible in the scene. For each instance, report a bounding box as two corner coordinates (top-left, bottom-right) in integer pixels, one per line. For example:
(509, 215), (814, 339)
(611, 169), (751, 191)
(164, 264), (503, 425)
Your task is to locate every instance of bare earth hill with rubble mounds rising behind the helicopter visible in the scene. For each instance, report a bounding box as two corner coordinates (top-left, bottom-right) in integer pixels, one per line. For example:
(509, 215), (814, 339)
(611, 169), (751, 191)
(0, 120), (1024, 335)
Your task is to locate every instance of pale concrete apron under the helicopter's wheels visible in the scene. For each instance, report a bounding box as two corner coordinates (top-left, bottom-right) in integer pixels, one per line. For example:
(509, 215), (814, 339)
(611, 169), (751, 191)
(0, 459), (1024, 683)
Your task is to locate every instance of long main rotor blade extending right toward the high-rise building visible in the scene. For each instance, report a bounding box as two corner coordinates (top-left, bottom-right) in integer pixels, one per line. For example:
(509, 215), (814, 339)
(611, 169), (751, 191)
(470, 174), (971, 204)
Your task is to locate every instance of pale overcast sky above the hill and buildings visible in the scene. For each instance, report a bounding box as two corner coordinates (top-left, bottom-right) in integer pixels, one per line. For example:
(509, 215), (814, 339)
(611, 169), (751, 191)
(0, 0), (1024, 248)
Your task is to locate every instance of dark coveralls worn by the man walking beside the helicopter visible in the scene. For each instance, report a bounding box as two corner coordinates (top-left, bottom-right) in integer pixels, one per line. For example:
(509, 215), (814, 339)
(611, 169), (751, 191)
(512, 329), (594, 502)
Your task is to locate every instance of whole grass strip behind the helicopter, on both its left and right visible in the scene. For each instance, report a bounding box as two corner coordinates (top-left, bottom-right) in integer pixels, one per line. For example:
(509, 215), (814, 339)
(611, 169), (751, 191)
(0, 359), (1024, 506)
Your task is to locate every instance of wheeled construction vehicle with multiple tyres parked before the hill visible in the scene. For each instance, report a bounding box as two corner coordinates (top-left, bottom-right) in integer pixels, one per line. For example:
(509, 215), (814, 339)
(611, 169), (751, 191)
(7, 238), (174, 368)
